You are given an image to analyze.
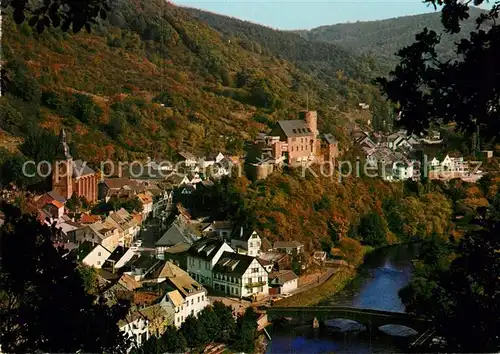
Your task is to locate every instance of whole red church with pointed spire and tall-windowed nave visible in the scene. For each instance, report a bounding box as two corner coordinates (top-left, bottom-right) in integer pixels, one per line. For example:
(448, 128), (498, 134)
(52, 128), (97, 203)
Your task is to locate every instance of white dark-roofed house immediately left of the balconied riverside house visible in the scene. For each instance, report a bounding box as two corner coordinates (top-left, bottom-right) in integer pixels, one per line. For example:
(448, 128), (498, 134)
(187, 238), (234, 286)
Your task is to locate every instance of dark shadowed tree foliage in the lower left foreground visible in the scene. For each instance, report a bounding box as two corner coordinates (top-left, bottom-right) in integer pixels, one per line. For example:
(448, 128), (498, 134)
(0, 205), (128, 353)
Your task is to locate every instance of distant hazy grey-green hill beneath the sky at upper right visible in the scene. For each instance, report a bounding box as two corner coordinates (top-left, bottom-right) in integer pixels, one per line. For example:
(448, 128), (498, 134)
(295, 8), (481, 69)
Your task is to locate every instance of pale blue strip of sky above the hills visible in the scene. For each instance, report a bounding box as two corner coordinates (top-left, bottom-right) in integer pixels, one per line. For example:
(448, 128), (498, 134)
(172, 0), (442, 29)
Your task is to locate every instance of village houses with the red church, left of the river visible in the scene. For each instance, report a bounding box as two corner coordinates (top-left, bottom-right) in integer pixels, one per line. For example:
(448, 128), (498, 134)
(4, 126), (304, 346)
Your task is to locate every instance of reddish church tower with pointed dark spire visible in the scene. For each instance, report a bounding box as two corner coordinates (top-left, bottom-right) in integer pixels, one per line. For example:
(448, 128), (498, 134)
(52, 128), (73, 199)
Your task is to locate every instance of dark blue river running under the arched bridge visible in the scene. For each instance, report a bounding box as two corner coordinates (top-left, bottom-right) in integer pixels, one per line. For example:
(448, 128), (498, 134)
(267, 245), (418, 354)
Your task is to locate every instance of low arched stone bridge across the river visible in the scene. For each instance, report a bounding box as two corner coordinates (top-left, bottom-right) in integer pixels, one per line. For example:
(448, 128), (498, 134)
(267, 306), (431, 333)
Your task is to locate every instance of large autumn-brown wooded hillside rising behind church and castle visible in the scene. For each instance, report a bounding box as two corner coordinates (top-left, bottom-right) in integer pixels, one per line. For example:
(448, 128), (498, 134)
(0, 0), (390, 183)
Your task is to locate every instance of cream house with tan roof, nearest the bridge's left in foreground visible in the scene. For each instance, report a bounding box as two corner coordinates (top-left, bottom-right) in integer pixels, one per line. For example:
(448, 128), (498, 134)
(160, 262), (209, 327)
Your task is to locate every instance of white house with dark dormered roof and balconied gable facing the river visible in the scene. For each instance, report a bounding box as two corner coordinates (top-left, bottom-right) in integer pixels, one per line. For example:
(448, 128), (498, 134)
(213, 252), (269, 297)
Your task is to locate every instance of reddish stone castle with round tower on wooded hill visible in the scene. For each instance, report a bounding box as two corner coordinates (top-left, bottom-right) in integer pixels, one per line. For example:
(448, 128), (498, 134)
(247, 111), (339, 179)
